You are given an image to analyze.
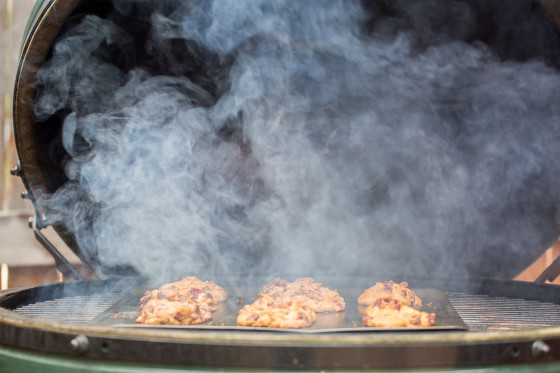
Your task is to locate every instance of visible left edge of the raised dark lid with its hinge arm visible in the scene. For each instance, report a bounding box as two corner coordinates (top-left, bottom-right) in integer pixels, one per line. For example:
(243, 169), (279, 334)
(11, 0), (139, 279)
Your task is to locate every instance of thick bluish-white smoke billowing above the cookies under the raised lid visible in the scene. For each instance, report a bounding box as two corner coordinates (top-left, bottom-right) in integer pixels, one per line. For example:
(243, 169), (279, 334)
(34, 0), (560, 278)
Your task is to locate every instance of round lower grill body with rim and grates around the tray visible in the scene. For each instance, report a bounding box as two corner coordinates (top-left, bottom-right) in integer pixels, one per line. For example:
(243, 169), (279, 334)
(0, 278), (560, 371)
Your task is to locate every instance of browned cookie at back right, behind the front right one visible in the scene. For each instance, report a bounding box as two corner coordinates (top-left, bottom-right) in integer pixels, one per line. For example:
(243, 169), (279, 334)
(358, 281), (422, 309)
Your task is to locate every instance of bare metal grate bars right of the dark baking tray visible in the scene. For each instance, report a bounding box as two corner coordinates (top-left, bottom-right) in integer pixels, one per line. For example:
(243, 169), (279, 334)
(447, 293), (560, 331)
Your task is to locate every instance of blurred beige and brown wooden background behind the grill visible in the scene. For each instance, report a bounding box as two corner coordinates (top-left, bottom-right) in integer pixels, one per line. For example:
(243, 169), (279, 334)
(0, 0), (560, 289)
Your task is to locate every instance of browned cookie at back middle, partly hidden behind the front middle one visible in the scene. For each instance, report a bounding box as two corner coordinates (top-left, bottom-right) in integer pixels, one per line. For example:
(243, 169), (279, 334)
(260, 277), (346, 312)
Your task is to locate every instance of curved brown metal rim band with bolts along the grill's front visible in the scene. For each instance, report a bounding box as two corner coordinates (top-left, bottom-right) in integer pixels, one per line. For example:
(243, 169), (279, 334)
(0, 309), (560, 369)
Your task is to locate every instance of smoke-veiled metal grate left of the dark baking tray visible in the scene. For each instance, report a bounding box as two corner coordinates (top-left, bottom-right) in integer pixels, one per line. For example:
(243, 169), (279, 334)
(14, 293), (122, 323)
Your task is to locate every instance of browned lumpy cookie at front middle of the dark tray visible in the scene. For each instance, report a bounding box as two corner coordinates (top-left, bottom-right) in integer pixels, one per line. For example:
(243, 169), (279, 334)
(237, 295), (317, 328)
